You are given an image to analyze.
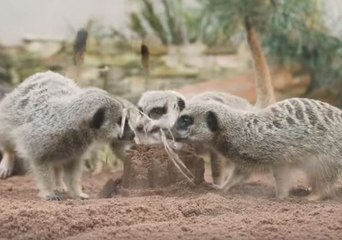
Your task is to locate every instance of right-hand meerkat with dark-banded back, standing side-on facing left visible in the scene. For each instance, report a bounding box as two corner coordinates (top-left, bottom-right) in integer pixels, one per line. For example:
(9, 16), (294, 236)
(172, 98), (342, 200)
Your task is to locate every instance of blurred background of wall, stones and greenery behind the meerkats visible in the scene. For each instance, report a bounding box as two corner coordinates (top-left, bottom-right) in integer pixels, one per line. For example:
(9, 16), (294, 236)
(0, 0), (342, 107)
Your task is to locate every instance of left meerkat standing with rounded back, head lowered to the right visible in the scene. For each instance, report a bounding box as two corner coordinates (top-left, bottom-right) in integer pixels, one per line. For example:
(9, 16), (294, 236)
(0, 71), (134, 200)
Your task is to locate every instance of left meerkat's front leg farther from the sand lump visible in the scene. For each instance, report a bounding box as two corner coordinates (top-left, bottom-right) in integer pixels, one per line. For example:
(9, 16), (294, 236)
(32, 162), (62, 201)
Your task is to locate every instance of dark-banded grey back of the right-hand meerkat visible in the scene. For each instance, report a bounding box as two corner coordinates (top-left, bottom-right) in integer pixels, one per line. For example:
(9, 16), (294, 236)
(247, 98), (342, 158)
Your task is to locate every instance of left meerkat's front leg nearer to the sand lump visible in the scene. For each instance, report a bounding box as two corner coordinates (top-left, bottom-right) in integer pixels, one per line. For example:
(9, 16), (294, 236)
(64, 159), (89, 199)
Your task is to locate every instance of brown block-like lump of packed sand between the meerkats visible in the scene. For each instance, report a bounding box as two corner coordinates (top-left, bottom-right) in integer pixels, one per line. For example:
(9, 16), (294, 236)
(99, 144), (204, 197)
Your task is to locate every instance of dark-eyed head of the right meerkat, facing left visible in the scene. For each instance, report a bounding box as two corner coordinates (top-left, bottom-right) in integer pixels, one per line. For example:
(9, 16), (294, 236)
(172, 102), (221, 144)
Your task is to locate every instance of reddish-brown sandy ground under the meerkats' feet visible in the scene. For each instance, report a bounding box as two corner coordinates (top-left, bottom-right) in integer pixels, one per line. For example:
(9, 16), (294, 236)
(0, 170), (342, 240)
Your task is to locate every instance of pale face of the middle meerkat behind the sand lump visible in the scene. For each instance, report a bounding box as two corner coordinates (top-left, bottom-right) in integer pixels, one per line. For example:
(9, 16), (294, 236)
(136, 91), (185, 141)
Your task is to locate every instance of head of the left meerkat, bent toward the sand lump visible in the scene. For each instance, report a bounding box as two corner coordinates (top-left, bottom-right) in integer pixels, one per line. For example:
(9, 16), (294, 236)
(74, 88), (134, 142)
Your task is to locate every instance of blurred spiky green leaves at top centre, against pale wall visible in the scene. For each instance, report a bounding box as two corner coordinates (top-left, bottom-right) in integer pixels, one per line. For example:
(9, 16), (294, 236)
(130, 0), (215, 45)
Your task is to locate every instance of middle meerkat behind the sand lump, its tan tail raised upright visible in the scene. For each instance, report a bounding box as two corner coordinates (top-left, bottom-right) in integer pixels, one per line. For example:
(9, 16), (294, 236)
(136, 17), (276, 184)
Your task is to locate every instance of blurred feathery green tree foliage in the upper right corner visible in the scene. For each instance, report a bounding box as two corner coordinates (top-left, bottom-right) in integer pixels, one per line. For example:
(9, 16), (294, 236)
(201, 0), (342, 87)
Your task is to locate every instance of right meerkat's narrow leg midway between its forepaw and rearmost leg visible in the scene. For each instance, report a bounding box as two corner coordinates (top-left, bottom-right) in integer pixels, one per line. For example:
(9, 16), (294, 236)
(272, 164), (293, 199)
